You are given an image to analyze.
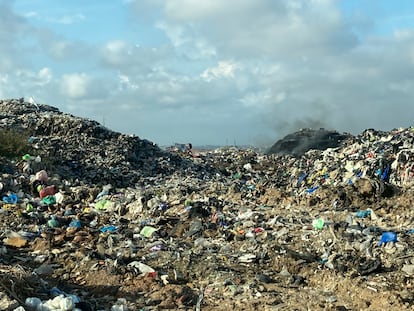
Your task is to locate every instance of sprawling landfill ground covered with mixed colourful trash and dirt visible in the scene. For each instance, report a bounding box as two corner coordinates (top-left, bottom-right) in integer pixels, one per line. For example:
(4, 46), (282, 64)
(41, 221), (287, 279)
(0, 99), (414, 311)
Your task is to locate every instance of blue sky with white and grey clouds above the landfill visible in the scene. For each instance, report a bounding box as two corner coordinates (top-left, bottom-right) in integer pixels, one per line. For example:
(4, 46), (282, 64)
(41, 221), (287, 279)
(0, 0), (414, 146)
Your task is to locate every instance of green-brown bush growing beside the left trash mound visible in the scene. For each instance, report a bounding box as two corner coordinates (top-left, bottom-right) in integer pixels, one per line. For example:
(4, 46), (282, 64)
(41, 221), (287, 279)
(0, 129), (31, 158)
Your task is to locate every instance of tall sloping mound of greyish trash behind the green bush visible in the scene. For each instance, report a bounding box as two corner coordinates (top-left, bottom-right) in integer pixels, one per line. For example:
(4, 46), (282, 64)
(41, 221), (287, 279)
(0, 99), (207, 186)
